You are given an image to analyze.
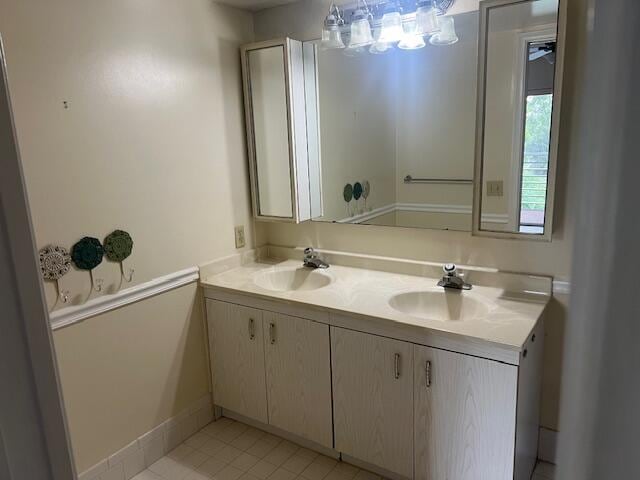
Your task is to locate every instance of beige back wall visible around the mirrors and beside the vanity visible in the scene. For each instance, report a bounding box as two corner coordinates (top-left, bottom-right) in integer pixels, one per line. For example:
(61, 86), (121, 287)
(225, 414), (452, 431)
(254, 0), (586, 429)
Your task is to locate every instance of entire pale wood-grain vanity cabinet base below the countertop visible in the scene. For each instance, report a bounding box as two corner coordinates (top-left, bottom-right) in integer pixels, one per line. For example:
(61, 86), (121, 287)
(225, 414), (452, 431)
(207, 290), (543, 480)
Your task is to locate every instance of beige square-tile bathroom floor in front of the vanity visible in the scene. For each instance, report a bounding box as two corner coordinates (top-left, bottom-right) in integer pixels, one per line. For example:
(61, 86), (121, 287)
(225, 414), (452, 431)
(133, 418), (554, 480)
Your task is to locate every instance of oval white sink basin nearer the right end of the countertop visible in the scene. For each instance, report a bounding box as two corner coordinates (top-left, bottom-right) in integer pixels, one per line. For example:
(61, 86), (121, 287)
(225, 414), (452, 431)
(389, 289), (489, 322)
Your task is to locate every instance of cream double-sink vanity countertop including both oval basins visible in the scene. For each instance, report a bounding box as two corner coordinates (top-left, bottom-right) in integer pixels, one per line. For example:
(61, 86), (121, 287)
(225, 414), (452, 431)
(200, 255), (551, 360)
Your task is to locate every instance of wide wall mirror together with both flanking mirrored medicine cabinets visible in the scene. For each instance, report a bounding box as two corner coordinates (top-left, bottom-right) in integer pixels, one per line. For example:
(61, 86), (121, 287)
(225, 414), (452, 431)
(242, 0), (565, 240)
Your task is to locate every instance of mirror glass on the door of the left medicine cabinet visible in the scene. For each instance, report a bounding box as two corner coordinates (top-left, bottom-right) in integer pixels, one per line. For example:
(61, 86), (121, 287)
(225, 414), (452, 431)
(247, 45), (293, 218)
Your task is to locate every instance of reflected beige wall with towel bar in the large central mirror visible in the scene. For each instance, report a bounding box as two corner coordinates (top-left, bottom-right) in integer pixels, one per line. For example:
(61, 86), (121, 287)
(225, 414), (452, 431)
(394, 12), (478, 208)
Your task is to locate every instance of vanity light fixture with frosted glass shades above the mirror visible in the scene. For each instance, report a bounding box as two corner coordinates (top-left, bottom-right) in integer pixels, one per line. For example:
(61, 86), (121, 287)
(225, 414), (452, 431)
(320, 0), (458, 57)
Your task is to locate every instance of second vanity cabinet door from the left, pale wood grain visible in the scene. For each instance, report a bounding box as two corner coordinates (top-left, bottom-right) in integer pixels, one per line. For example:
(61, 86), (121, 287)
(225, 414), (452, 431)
(263, 312), (333, 448)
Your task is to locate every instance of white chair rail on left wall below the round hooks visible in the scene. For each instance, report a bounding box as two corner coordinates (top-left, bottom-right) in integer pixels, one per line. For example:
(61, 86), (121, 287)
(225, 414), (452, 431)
(49, 267), (199, 330)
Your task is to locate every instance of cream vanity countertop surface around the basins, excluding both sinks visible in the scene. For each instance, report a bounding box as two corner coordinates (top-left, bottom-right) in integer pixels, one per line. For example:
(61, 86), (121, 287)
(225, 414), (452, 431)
(201, 260), (549, 352)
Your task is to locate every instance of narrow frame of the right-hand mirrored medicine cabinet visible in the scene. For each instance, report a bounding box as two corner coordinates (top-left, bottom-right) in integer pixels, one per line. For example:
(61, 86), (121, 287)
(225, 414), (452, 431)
(471, 0), (567, 242)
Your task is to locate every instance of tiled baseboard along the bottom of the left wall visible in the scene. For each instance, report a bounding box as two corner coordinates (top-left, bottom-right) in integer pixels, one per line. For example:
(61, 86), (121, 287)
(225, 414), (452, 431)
(78, 394), (213, 480)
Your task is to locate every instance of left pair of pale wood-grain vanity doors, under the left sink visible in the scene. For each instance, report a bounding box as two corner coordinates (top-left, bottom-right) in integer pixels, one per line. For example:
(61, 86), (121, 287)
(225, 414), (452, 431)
(207, 300), (333, 448)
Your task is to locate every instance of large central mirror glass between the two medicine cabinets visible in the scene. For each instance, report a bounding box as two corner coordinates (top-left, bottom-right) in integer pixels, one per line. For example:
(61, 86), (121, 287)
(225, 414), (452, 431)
(305, 12), (478, 231)
